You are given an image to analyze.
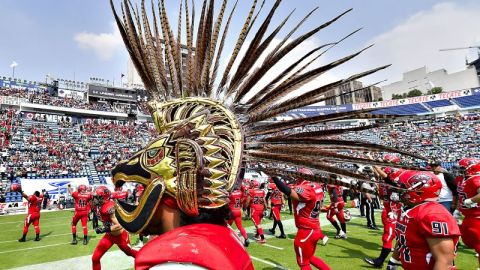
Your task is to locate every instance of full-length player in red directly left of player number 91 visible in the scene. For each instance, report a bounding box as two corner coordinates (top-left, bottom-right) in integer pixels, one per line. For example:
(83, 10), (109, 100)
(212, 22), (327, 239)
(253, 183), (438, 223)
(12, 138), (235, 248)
(365, 166), (405, 268)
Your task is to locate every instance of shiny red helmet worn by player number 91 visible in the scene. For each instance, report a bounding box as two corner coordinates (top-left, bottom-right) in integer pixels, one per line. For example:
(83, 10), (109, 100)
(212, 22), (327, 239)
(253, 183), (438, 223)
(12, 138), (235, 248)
(399, 170), (442, 204)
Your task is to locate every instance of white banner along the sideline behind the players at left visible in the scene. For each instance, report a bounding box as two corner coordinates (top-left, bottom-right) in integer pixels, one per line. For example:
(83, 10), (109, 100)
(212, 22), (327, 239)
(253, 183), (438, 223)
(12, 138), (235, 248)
(20, 177), (89, 201)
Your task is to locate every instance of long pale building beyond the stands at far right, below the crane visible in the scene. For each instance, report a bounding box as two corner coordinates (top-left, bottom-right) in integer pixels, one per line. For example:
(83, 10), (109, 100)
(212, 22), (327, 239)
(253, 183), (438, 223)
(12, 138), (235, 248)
(382, 65), (480, 100)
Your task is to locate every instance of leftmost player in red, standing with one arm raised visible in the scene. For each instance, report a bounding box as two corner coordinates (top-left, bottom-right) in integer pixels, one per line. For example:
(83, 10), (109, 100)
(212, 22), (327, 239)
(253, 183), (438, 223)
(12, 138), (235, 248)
(10, 184), (43, 242)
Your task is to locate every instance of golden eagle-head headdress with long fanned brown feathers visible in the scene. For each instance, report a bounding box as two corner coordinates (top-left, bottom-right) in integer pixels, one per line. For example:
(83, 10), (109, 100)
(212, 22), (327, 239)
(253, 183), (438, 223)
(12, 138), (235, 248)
(111, 0), (417, 231)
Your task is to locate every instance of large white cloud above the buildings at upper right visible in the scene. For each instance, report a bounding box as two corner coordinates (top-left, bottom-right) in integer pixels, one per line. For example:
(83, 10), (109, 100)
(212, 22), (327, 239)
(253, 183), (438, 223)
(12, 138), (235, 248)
(359, 2), (480, 84)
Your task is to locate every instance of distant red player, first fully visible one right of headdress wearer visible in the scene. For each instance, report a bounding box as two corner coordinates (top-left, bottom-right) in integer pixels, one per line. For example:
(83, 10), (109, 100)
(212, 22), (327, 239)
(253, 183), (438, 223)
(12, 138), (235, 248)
(247, 180), (267, 244)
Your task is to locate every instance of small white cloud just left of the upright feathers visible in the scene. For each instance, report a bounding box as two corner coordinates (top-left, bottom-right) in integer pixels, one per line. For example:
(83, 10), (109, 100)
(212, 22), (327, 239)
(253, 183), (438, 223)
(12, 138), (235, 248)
(74, 25), (123, 61)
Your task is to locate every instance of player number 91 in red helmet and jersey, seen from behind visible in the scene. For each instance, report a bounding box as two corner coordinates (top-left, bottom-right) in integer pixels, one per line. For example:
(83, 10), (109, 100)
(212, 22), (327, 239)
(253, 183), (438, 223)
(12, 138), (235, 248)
(387, 170), (460, 270)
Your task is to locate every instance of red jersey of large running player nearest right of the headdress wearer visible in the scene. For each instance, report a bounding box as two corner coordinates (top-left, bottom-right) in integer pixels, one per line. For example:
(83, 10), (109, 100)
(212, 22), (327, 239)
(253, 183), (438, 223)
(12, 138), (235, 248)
(292, 182), (324, 229)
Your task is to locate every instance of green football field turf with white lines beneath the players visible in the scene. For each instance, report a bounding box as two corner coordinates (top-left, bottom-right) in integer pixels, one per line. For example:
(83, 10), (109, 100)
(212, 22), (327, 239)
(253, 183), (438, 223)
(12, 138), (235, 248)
(0, 210), (477, 270)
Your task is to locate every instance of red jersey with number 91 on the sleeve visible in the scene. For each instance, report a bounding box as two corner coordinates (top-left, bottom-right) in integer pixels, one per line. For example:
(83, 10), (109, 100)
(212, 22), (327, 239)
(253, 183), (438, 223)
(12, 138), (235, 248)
(396, 202), (460, 270)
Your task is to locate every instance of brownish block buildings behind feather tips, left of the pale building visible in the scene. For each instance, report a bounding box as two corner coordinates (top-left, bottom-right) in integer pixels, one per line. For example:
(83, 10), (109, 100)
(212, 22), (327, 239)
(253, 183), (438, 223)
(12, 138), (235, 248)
(325, 81), (382, 105)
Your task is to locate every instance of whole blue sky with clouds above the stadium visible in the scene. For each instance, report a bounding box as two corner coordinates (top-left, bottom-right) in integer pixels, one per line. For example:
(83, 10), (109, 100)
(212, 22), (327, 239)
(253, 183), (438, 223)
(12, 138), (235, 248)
(0, 0), (480, 86)
